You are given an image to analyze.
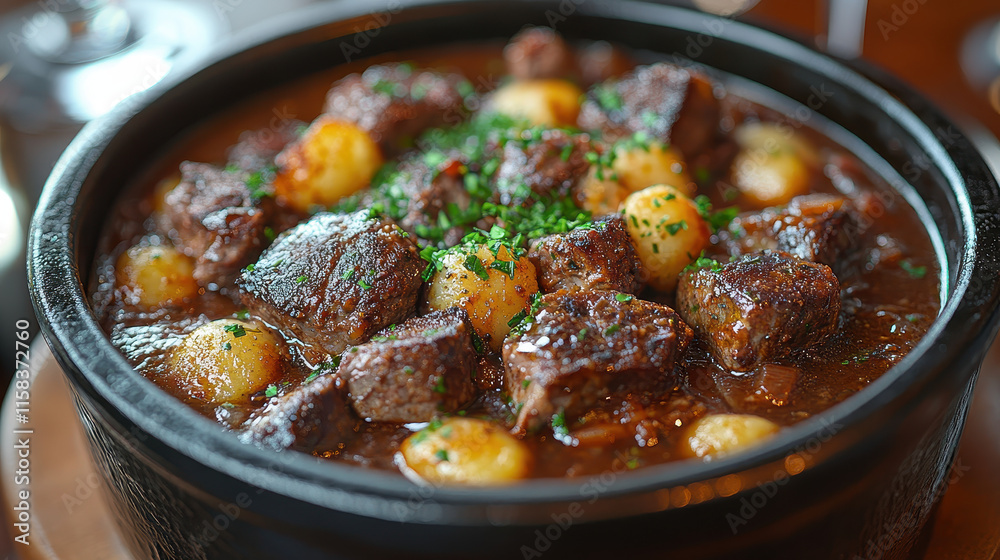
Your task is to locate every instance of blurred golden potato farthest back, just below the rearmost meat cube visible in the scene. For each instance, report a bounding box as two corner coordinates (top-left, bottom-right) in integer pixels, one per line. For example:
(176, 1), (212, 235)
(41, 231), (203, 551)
(493, 80), (583, 127)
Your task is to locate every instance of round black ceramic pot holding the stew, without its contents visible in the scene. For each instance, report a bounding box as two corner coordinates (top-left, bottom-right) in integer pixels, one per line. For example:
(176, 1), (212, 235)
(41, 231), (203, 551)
(29, 0), (1000, 560)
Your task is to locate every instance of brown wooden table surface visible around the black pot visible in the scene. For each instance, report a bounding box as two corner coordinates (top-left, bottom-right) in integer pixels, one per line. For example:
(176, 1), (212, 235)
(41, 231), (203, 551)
(0, 0), (1000, 560)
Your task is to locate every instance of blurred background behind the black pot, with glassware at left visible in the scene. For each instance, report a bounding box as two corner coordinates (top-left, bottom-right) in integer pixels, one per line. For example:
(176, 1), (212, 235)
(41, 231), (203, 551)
(0, 0), (1000, 558)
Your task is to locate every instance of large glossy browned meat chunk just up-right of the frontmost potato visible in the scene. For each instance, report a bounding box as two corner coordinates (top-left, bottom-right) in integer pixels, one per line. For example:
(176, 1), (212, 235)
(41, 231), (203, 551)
(503, 291), (693, 433)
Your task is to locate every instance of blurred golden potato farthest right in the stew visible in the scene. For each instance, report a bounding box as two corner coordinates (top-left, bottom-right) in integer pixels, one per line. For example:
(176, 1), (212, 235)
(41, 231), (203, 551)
(732, 123), (819, 207)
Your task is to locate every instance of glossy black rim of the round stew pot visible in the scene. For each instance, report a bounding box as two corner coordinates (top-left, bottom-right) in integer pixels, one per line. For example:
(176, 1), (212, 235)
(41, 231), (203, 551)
(28, 0), (1000, 517)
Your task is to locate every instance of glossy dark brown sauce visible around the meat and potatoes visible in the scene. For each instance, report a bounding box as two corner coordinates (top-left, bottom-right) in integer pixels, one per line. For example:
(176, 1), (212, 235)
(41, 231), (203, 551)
(91, 45), (940, 477)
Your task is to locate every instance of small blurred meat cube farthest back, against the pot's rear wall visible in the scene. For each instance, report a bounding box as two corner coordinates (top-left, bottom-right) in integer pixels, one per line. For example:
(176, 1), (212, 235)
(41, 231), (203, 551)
(503, 27), (574, 80)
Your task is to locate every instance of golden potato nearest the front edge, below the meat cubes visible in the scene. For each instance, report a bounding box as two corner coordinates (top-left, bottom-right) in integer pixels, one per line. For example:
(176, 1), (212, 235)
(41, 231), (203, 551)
(400, 418), (532, 485)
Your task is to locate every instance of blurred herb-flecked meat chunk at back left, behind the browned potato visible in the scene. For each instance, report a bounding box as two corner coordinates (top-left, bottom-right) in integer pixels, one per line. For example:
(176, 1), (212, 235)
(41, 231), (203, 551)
(324, 64), (468, 155)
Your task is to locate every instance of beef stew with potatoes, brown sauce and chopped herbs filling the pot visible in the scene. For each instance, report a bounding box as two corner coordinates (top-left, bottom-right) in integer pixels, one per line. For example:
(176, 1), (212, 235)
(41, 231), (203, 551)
(91, 28), (940, 484)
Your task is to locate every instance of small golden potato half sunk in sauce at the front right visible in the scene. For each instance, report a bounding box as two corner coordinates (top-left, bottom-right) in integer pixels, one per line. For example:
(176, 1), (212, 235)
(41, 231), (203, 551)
(682, 414), (781, 457)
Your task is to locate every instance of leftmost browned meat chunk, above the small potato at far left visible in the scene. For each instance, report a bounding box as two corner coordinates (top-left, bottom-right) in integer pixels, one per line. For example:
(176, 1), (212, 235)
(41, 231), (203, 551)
(164, 162), (275, 287)
